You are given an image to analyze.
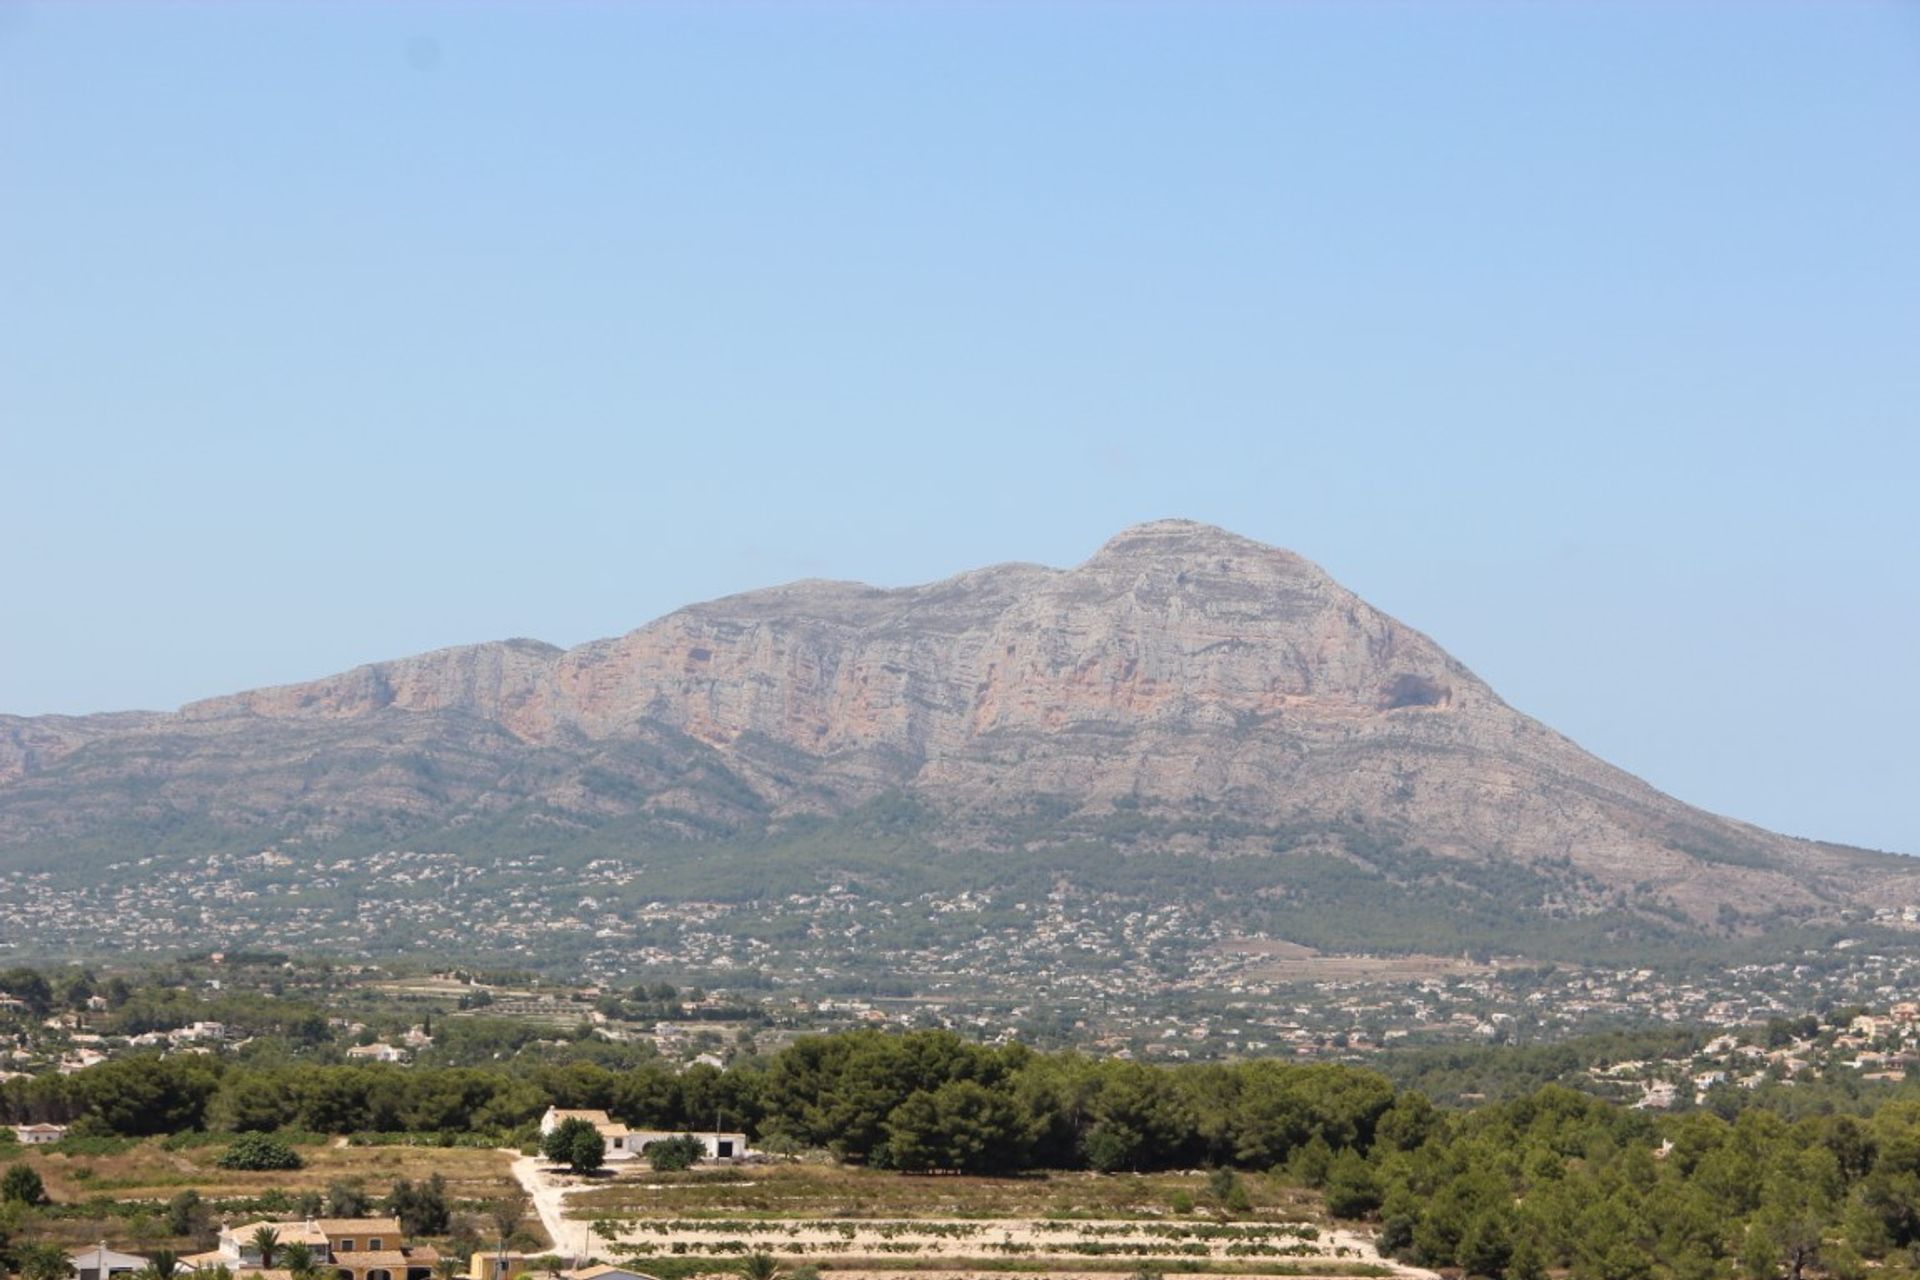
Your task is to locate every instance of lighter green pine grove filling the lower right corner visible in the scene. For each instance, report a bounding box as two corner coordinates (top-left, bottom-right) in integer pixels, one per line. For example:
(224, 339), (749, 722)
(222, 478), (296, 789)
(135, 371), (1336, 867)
(1374, 1086), (1920, 1280)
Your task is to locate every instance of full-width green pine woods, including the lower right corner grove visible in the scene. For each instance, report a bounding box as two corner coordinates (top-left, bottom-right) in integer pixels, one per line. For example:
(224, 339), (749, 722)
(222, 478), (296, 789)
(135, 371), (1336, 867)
(11, 1031), (1920, 1280)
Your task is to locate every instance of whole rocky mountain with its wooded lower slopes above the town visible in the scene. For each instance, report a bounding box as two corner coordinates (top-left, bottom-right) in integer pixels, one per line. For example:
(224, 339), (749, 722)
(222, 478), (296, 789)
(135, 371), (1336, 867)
(0, 520), (1920, 959)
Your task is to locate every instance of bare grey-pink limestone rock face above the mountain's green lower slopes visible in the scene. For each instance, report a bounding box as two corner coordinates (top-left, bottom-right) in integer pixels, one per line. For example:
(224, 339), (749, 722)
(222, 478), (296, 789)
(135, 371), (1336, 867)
(0, 520), (1912, 917)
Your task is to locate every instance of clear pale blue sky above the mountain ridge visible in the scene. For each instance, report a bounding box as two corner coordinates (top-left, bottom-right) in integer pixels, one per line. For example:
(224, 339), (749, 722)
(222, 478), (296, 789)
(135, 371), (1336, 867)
(0, 0), (1920, 854)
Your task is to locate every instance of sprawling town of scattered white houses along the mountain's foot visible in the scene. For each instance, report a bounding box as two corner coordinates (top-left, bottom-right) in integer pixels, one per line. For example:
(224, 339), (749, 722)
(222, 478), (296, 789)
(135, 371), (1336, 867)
(0, 850), (1920, 1069)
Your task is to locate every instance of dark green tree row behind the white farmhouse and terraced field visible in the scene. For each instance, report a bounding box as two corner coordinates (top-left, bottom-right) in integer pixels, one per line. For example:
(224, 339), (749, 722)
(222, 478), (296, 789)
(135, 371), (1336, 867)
(0, 1031), (1396, 1173)
